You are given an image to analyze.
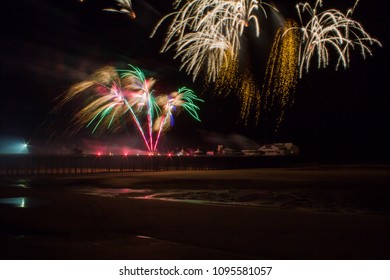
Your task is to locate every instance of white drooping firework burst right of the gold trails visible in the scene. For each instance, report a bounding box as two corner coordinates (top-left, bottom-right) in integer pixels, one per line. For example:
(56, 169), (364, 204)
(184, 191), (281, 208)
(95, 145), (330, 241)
(294, 0), (381, 77)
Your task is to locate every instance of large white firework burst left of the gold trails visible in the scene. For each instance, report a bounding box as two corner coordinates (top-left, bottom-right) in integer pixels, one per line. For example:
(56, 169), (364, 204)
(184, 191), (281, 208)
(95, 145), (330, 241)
(151, 0), (274, 81)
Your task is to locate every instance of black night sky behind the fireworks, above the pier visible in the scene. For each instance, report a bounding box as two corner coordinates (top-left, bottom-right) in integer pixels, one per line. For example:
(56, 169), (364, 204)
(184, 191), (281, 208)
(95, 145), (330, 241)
(0, 0), (390, 160)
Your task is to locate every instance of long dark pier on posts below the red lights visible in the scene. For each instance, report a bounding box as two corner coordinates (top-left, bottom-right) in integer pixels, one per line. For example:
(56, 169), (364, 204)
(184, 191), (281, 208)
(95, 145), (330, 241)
(0, 155), (296, 175)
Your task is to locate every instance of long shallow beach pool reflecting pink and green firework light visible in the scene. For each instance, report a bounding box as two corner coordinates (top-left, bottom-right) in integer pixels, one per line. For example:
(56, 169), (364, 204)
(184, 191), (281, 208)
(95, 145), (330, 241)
(76, 187), (383, 213)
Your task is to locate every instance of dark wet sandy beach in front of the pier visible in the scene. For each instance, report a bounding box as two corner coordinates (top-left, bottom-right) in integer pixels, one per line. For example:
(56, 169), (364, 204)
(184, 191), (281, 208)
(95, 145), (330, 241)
(0, 165), (390, 260)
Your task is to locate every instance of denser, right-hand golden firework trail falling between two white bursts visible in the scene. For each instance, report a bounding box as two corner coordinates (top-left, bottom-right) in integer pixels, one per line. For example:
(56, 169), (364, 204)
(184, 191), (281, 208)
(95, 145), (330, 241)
(257, 20), (300, 124)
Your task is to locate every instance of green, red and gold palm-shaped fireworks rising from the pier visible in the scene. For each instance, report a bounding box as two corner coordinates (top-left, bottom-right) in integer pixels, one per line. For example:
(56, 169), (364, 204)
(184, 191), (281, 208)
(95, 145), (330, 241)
(55, 65), (203, 152)
